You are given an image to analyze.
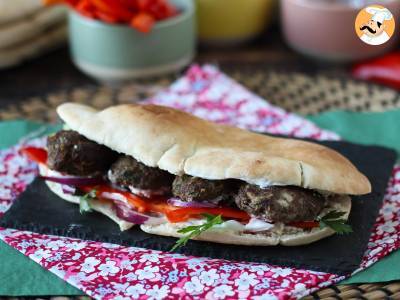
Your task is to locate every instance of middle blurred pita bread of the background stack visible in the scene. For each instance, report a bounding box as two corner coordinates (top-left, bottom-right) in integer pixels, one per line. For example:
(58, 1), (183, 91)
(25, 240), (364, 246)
(0, 6), (66, 49)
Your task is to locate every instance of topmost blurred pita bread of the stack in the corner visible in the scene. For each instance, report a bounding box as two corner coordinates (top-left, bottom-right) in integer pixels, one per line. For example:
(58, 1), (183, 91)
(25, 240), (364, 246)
(0, 0), (43, 24)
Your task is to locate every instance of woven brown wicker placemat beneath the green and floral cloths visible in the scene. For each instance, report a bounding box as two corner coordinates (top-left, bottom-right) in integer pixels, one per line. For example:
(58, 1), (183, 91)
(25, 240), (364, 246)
(0, 67), (400, 300)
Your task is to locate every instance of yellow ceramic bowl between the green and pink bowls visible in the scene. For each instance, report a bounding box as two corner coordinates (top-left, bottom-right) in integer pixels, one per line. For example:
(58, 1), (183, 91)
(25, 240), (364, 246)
(196, 0), (277, 46)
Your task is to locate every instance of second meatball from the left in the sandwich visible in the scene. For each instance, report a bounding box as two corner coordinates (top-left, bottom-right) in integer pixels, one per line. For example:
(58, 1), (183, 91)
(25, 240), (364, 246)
(108, 156), (174, 190)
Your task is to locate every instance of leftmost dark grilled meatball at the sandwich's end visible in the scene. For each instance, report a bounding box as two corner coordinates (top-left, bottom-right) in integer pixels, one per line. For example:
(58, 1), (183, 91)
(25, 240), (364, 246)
(47, 130), (118, 176)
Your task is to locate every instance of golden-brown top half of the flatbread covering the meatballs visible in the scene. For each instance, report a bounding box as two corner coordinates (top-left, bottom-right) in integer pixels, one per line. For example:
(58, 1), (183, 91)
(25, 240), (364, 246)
(57, 103), (371, 196)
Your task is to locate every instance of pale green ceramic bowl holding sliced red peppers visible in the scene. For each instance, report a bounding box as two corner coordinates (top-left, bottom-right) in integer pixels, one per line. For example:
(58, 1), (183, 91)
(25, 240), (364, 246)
(69, 0), (196, 83)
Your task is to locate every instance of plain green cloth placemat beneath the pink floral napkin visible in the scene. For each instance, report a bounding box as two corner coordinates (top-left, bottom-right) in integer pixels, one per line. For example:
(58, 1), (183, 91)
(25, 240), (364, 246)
(0, 110), (400, 296)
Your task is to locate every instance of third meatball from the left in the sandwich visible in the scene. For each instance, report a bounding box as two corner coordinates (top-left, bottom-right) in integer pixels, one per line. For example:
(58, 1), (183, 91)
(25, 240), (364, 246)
(172, 175), (235, 202)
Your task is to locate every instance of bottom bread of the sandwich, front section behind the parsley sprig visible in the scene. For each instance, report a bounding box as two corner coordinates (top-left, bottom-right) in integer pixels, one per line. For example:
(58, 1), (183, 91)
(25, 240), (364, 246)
(140, 196), (351, 246)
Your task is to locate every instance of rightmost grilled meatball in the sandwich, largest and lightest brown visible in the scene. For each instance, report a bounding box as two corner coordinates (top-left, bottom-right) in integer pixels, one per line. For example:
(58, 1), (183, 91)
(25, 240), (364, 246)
(235, 184), (325, 223)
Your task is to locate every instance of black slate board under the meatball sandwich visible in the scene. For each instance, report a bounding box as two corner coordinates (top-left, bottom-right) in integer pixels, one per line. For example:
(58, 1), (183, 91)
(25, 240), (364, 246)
(0, 142), (396, 275)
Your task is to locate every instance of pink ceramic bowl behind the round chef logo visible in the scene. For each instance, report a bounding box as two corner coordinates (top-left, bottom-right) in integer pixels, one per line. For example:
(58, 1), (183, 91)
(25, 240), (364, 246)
(281, 0), (400, 62)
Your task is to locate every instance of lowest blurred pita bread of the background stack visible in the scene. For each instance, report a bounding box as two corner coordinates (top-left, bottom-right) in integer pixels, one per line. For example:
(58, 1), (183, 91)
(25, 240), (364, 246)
(0, 24), (67, 68)
